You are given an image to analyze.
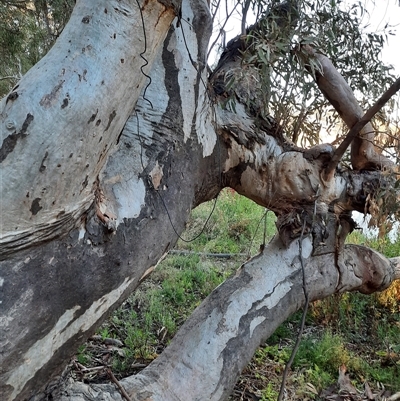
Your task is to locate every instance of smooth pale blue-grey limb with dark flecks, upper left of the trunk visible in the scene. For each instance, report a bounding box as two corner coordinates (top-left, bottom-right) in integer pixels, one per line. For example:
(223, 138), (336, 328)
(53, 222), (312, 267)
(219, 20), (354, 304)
(0, 0), (175, 259)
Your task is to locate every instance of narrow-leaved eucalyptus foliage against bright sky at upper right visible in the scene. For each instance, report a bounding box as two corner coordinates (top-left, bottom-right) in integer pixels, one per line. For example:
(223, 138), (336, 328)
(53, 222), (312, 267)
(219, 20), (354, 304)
(236, 0), (398, 150)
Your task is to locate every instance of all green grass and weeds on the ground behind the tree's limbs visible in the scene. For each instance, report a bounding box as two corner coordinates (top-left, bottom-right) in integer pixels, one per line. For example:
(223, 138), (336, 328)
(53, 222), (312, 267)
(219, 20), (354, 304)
(76, 190), (400, 401)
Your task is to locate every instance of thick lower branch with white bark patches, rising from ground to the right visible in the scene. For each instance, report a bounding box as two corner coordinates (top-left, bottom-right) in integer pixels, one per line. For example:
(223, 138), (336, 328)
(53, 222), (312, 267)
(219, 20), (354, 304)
(51, 236), (400, 401)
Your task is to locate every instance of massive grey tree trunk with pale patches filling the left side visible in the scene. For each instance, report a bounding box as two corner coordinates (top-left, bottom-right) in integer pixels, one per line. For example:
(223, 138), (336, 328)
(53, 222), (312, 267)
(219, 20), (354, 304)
(0, 1), (222, 400)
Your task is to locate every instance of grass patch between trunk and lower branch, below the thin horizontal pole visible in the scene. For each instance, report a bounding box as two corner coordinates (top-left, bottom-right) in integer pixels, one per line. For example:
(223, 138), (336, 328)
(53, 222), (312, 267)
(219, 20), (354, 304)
(94, 255), (231, 376)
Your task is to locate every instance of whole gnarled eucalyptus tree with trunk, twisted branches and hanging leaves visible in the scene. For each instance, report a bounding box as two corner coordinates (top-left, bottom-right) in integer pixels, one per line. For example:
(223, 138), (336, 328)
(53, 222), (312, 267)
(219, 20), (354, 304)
(0, 0), (400, 400)
